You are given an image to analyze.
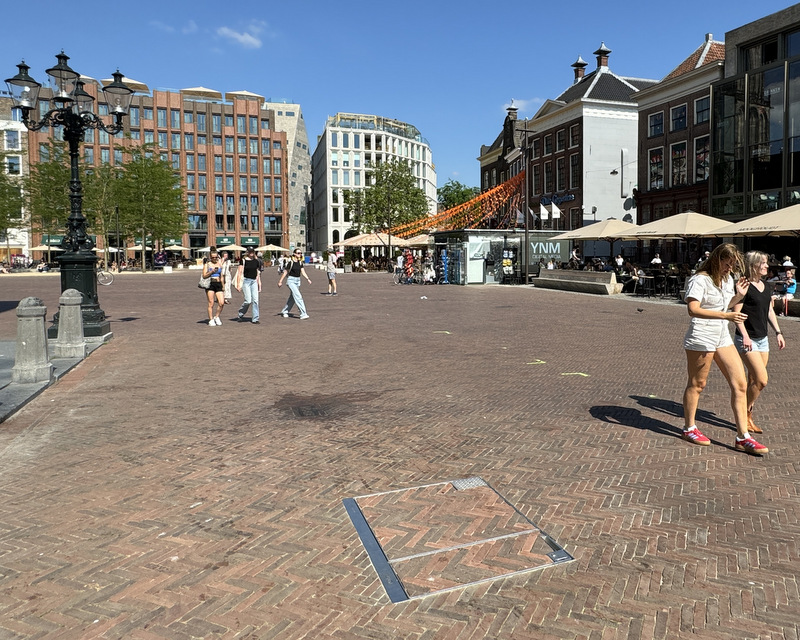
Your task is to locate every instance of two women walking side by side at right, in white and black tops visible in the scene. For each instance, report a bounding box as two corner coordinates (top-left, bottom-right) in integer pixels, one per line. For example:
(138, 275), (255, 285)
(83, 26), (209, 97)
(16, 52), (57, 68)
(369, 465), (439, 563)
(683, 243), (786, 455)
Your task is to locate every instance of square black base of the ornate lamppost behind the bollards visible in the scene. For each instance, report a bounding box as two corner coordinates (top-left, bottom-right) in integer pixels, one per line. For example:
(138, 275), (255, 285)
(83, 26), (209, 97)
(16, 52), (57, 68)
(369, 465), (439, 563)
(47, 251), (112, 339)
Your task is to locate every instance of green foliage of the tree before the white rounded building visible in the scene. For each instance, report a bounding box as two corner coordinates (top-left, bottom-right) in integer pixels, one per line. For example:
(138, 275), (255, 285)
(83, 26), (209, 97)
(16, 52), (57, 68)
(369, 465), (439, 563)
(345, 160), (428, 233)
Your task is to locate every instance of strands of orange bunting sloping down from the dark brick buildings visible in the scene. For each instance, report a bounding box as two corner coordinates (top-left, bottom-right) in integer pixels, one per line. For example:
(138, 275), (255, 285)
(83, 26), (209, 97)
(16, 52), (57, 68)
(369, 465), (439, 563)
(389, 171), (525, 238)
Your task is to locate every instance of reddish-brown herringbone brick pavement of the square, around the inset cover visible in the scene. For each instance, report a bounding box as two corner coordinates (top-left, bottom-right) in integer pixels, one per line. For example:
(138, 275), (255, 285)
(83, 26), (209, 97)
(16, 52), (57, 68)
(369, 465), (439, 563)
(0, 272), (800, 640)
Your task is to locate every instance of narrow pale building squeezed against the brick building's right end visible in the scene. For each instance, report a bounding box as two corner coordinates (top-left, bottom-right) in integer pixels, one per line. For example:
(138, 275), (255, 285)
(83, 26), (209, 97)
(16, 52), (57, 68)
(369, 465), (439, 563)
(264, 100), (311, 249)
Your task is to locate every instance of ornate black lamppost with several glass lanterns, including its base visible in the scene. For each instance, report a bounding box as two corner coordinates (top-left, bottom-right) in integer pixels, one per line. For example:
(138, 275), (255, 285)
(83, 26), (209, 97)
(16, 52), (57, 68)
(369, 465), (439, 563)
(6, 51), (133, 337)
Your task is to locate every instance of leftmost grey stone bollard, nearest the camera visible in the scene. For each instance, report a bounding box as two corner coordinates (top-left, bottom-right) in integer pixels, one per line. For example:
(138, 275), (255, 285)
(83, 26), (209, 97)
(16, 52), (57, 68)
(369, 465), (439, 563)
(11, 297), (53, 382)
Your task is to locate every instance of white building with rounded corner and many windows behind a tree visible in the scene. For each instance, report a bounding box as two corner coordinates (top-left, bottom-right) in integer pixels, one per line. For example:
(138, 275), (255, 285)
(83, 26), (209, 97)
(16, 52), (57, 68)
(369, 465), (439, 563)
(309, 113), (437, 251)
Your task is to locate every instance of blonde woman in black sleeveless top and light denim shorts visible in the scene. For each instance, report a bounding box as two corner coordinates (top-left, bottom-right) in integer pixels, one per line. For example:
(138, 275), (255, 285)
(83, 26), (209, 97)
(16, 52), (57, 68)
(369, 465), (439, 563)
(733, 251), (786, 433)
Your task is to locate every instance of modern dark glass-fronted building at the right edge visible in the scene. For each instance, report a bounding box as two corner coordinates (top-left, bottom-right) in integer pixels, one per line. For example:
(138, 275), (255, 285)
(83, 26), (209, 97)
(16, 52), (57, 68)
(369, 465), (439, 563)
(711, 5), (800, 221)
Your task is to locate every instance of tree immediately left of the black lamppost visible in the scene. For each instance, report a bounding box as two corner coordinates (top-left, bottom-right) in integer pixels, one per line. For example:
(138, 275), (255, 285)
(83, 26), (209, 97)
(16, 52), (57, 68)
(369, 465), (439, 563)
(24, 141), (70, 261)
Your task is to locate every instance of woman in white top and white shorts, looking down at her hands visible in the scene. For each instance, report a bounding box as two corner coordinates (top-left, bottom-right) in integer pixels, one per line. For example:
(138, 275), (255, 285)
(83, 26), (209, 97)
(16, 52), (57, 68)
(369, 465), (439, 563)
(683, 244), (769, 455)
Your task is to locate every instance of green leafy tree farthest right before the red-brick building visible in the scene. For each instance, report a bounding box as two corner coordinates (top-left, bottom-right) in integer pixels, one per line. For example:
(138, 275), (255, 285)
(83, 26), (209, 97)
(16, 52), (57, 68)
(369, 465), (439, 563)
(117, 145), (187, 271)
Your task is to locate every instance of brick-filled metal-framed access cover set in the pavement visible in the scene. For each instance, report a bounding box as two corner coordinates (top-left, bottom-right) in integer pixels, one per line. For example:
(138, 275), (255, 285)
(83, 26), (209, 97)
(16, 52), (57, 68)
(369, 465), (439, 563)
(343, 476), (573, 602)
